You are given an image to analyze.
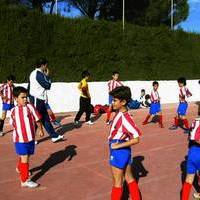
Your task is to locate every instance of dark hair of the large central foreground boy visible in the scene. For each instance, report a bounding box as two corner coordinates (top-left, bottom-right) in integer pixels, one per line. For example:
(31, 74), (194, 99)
(109, 86), (131, 104)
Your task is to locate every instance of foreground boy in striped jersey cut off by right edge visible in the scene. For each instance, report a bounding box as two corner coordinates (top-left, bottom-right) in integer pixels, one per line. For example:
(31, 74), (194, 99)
(181, 118), (200, 200)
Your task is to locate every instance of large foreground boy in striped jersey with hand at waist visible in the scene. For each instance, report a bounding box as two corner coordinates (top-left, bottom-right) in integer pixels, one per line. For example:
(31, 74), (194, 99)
(108, 86), (141, 200)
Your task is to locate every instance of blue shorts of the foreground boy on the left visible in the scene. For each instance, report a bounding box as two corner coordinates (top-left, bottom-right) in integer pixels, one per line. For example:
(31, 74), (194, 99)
(15, 141), (35, 156)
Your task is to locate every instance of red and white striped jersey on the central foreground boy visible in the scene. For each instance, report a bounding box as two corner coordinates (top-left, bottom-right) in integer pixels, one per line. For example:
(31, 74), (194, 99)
(108, 112), (141, 141)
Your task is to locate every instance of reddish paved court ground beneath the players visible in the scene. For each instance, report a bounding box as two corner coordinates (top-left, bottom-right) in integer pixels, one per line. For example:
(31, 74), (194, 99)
(0, 104), (197, 200)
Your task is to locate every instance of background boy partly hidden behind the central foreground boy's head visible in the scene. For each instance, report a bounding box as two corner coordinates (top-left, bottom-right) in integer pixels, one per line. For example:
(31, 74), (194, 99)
(106, 71), (123, 125)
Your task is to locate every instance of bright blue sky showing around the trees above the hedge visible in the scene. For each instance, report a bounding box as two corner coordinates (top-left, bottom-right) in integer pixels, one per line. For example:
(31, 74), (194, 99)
(47, 0), (200, 33)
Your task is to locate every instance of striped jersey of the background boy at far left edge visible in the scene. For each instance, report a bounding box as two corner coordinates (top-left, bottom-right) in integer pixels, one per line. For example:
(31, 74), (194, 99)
(0, 83), (14, 104)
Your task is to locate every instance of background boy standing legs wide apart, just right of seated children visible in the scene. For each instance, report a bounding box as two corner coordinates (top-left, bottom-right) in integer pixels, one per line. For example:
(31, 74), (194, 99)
(142, 81), (164, 128)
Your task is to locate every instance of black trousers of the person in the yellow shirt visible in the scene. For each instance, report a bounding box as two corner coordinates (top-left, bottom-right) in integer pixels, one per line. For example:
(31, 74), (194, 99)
(74, 97), (91, 122)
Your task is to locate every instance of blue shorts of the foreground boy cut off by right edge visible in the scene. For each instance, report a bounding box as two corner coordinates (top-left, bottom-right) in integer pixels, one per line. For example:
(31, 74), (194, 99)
(186, 146), (200, 174)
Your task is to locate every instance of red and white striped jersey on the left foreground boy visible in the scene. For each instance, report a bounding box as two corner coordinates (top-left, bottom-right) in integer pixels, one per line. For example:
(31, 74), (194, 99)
(10, 103), (41, 143)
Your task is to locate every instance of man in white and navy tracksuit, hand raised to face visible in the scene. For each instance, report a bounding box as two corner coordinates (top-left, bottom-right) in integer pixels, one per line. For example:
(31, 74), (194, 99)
(28, 58), (63, 142)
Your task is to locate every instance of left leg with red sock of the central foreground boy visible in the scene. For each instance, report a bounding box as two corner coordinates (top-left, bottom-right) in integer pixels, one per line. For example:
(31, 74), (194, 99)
(111, 166), (124, 200)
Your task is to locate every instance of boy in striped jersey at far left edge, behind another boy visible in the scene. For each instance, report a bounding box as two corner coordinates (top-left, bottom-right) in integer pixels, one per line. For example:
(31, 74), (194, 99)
(0, 75), (15, 136)
